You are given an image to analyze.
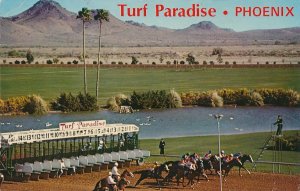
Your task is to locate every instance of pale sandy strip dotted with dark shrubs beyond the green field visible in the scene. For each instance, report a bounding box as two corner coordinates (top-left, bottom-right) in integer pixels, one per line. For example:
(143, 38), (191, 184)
(0, 45), (300, 65)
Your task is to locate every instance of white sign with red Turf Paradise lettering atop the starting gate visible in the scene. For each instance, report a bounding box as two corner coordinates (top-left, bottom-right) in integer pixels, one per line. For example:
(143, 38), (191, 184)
(59, 120), (106, 131)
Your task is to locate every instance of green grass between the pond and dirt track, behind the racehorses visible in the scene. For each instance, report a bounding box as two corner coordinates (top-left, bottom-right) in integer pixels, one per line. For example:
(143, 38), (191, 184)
(140, 131), (300, 174)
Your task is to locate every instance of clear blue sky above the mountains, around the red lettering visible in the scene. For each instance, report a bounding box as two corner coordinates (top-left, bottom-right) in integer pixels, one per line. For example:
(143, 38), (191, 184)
(0, 0), (300, 31)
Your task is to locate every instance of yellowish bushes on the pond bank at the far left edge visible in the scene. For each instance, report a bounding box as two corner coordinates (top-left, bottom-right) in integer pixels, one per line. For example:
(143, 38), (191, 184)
(0, 95), (49, 114)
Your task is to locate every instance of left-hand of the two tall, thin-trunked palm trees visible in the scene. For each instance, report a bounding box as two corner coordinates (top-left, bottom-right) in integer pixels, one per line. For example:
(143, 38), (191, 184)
(77, 7), (91, 94)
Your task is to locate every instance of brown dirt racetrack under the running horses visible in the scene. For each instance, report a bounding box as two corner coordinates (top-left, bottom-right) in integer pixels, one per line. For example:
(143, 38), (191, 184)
(1, 166), (300, 191)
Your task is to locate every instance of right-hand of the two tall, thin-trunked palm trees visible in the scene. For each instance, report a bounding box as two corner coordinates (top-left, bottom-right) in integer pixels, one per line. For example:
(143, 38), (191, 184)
(94, 9), (109, 101)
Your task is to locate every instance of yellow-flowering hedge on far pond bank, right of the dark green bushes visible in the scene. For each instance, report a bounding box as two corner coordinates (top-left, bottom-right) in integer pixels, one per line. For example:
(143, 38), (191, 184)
(180, 88), (300, 107)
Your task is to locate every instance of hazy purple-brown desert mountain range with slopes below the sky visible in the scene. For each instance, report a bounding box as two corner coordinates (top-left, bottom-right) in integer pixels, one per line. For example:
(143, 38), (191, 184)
(0, 0), (300, 46)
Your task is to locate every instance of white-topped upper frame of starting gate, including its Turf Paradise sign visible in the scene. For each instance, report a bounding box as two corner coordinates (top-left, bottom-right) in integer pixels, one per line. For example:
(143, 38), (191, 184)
(0, 120), (139, 173)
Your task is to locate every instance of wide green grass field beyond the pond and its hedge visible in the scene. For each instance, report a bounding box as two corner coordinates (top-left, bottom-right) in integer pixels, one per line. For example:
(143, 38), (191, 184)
(0, 67), (300, 105)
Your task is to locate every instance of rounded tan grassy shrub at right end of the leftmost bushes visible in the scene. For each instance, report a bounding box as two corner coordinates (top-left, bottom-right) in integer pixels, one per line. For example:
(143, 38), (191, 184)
(24, 95), (49, 115)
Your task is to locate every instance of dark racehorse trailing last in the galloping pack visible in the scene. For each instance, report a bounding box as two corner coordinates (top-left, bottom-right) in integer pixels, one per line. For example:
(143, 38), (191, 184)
(133, 163), (169, 187)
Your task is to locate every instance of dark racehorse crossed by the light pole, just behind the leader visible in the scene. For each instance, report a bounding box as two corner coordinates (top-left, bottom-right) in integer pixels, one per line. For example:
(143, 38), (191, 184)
(210, 155), (242, 181)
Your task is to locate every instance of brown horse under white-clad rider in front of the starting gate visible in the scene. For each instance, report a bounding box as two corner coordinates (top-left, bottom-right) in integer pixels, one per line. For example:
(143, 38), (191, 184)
(93, 169), (134, 191)
